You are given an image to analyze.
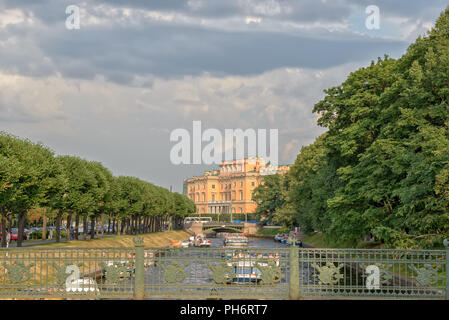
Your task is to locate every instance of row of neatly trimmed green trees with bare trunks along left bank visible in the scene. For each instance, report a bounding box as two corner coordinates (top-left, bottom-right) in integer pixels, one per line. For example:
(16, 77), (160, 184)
(0, 132), (196, 247)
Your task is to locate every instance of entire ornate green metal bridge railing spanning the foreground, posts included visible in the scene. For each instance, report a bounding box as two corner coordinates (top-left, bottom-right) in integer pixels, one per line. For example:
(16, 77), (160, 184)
(0, 238), (449, 299)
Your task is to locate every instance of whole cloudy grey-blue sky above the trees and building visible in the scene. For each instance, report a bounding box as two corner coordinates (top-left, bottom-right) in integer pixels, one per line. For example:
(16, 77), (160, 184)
(0, 0), (448, 191)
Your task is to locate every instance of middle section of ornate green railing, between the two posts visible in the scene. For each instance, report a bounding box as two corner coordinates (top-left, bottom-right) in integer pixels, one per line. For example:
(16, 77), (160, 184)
(145, 248), (289, 299)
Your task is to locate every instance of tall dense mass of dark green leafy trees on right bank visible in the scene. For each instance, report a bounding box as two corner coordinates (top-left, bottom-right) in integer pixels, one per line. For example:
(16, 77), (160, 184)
(255, 8), (449, 248)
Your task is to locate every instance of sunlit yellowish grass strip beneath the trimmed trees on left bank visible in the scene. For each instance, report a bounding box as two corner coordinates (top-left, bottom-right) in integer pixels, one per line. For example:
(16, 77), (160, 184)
(27, 230), (190, 248)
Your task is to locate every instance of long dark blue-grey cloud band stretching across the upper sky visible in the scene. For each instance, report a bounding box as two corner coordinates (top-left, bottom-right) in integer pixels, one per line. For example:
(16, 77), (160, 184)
(10, 24), (407, 83)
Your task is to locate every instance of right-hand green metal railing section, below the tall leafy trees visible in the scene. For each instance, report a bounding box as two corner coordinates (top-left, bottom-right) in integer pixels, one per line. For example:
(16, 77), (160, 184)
(299, 249), (448, 299)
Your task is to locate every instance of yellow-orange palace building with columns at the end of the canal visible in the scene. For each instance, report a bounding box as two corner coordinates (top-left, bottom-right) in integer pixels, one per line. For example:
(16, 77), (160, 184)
(184, 157), (290, 214)
